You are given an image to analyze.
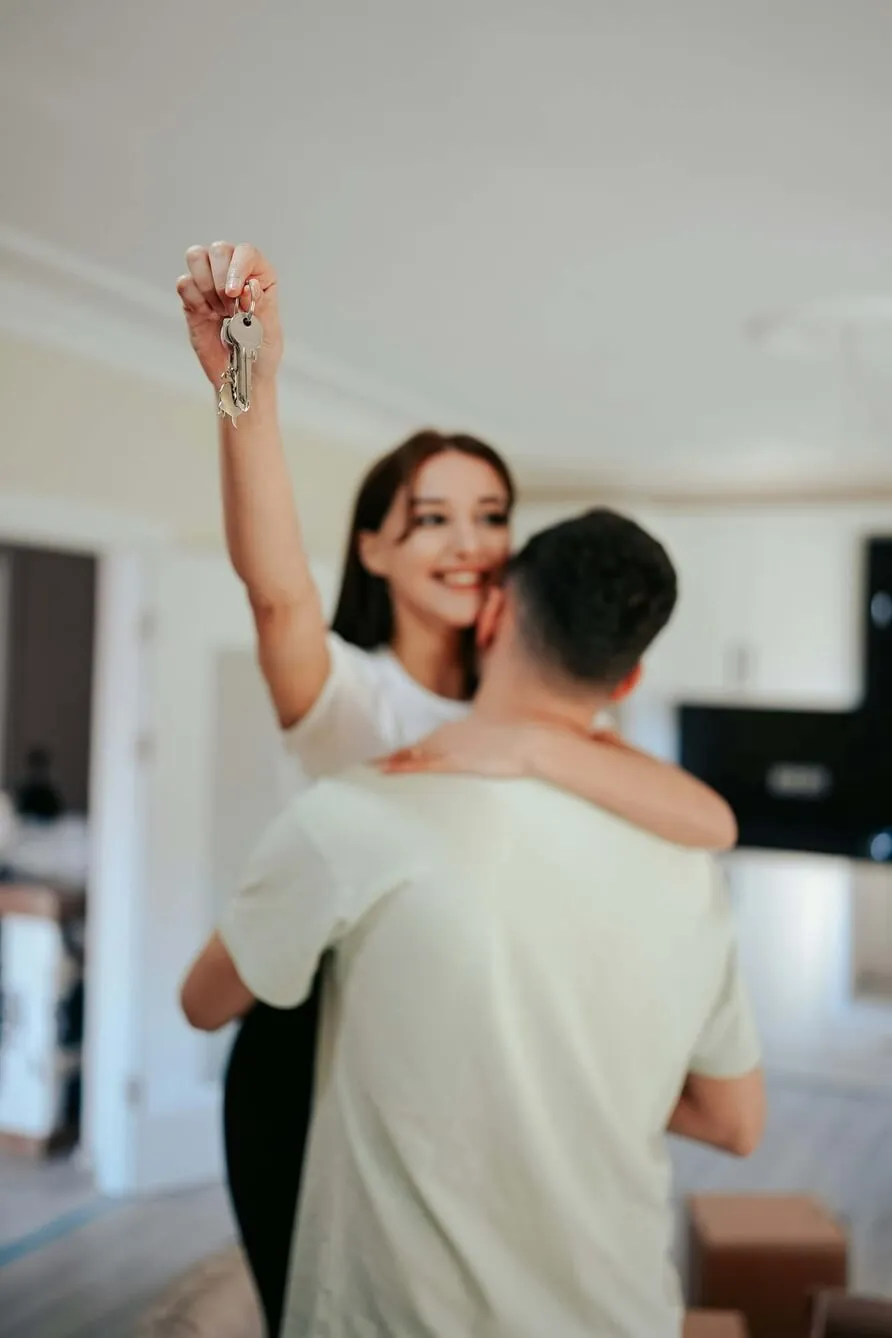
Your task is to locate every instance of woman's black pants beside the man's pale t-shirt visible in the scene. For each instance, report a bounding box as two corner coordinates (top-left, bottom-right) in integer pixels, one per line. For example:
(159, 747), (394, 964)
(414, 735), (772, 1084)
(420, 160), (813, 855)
(223, 973), (321, 1338)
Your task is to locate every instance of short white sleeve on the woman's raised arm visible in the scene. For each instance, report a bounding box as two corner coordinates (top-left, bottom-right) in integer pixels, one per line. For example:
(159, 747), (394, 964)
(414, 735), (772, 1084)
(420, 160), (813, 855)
(285, 633), (391, 780)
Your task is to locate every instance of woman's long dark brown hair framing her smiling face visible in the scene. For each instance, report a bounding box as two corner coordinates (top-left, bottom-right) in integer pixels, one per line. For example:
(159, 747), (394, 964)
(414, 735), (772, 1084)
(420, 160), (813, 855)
(332, 429), (515, 696)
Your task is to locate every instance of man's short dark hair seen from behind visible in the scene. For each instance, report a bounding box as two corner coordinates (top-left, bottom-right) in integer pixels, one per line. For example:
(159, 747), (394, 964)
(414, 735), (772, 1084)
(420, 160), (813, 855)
(507, 507), (678, 686)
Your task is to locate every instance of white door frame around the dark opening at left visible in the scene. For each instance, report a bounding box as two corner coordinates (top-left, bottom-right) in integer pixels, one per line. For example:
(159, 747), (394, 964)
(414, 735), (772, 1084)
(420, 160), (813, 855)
(0, 492), (173, 1195)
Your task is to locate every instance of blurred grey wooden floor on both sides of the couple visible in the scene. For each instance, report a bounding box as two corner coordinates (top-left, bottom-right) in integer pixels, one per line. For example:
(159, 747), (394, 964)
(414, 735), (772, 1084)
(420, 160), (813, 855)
(0, 1081), (892, 1338)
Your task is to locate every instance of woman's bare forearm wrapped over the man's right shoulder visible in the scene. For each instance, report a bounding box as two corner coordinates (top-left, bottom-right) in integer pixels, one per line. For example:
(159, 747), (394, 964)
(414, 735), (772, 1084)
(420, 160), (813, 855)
(530, 731), (737, 851)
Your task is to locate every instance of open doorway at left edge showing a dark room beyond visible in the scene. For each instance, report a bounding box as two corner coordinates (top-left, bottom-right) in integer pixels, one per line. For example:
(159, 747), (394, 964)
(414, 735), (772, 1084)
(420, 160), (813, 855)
(0, 543), (98, 1236)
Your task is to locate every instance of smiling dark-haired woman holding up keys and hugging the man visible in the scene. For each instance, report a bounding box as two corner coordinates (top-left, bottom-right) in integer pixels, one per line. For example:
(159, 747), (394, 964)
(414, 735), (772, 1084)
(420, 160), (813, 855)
(178, 242), (736, 1334)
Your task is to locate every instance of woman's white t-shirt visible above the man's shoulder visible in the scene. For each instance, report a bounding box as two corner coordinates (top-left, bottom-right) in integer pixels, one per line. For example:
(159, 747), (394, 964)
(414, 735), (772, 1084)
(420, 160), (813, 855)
(285, 633), (468, 783)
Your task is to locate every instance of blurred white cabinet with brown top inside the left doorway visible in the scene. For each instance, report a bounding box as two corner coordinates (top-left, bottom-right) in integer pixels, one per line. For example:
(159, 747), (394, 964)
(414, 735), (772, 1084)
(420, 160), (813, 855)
(0, 882), (84, 1155)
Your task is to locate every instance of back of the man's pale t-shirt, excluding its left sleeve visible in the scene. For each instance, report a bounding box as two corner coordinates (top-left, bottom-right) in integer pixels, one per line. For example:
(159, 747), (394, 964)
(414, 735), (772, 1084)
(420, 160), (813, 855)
(280, 772), (756, 1338)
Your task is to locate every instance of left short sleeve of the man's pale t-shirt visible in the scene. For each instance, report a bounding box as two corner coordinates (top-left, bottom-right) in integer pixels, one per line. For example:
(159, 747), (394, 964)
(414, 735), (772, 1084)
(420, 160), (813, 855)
(219, 796), (344, 1008)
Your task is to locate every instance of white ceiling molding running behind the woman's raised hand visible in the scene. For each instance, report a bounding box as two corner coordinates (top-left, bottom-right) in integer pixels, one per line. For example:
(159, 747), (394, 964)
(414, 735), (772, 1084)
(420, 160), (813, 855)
(0, 225), (489, 455)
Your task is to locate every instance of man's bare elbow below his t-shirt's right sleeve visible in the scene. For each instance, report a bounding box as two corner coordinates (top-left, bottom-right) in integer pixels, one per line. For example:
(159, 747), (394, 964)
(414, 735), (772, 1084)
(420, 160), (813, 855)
(669, 1069), (765, 1157)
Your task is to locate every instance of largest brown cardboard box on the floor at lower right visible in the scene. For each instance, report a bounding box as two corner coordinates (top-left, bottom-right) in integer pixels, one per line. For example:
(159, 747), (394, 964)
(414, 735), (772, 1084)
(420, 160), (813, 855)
(687, 1195), (848, 1338)
